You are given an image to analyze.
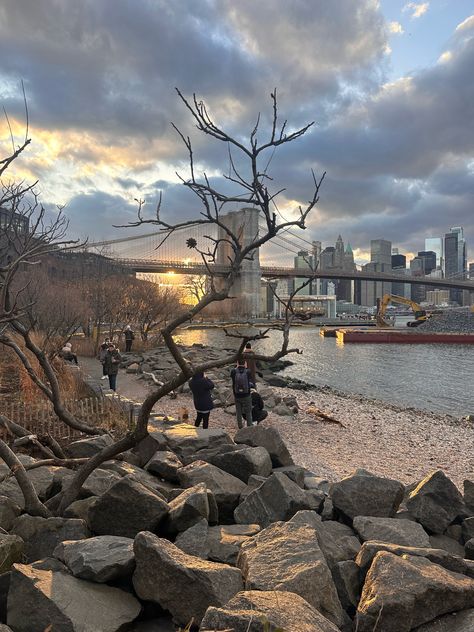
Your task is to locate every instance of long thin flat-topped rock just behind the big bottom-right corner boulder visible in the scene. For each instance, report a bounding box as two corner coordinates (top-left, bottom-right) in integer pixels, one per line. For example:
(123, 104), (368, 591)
(355, 541), (469, 575)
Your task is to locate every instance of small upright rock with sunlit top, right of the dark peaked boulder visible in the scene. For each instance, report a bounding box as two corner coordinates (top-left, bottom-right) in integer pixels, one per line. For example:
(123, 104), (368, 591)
(166, 483), (209, 534)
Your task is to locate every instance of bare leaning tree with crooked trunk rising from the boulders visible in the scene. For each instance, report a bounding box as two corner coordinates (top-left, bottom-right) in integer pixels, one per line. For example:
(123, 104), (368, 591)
(51, 90), (324, 514)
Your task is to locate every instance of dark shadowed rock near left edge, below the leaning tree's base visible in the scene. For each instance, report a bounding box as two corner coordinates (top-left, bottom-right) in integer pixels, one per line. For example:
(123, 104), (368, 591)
(11, 514), (89, 562)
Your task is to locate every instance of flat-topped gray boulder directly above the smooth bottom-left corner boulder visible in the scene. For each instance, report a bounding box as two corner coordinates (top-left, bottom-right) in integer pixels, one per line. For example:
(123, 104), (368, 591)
(54, 535), (135, 584)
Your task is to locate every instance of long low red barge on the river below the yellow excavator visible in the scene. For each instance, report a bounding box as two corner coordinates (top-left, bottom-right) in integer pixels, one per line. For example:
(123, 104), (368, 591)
(336, 328), (474, 345)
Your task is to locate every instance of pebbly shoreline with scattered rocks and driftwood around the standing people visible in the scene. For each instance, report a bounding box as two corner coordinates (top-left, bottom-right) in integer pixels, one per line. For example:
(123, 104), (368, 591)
(117, 345), (474, 489)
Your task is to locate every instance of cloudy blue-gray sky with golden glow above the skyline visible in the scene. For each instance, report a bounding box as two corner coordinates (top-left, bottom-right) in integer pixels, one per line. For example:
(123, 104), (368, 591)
(0, 0), (474, 260)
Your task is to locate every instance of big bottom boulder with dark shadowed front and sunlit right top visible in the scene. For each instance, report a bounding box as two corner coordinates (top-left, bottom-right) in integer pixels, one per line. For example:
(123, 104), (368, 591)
(133, 532), (243, 625)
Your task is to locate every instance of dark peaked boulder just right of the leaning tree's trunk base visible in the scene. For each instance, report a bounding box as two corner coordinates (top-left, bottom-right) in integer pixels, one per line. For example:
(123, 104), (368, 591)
(87, 476), (168, 539)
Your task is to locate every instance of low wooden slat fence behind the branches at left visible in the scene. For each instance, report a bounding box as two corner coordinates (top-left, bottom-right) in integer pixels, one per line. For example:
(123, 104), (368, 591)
(0, 394), (136, 442)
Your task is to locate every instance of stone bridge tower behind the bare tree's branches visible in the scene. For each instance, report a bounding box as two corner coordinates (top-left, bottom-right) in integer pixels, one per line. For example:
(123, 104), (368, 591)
(216, 208), (262, 316)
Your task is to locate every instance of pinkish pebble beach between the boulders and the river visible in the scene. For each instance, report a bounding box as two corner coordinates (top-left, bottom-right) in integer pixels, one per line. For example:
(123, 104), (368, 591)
(78, 349), (474, 488)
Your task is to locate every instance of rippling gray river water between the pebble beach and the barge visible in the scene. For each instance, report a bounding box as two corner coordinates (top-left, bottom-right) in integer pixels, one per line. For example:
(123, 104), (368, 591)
(178, 327), (474, 416)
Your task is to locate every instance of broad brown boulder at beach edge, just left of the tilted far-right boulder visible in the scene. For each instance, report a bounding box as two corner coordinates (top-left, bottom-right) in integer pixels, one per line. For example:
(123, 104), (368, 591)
(330, 470), (404, 519)
